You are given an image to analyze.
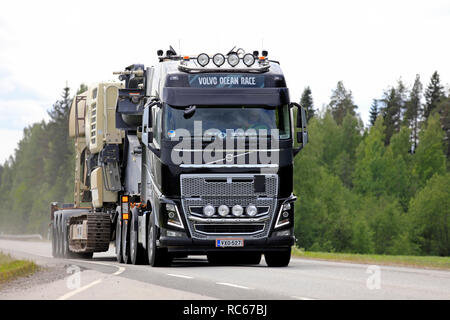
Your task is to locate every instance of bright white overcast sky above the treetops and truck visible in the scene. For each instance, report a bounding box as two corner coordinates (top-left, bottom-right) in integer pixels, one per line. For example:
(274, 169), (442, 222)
(0, 0), (450, 162)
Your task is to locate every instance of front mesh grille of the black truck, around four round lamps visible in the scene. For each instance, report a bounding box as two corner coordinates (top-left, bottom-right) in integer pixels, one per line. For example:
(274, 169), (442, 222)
(180, 174), (278, 239)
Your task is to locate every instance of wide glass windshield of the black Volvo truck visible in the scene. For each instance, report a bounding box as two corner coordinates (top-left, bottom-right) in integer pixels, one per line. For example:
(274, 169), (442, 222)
(163, 104), (290, 139)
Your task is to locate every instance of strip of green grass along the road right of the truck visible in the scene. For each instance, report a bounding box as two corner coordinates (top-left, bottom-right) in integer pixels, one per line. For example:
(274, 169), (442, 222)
(292, 248), (450, 270)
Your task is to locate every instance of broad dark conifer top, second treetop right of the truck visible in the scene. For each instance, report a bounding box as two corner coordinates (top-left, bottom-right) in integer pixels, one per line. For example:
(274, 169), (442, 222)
(329, 81), (358, 125)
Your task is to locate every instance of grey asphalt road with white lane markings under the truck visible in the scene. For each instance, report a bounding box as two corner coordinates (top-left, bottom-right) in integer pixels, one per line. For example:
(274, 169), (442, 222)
(0, 240), (450, 300)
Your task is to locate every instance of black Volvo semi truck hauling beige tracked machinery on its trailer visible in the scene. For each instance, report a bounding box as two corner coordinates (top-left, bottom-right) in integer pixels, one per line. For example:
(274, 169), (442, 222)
(51, 48), (308, 267)
